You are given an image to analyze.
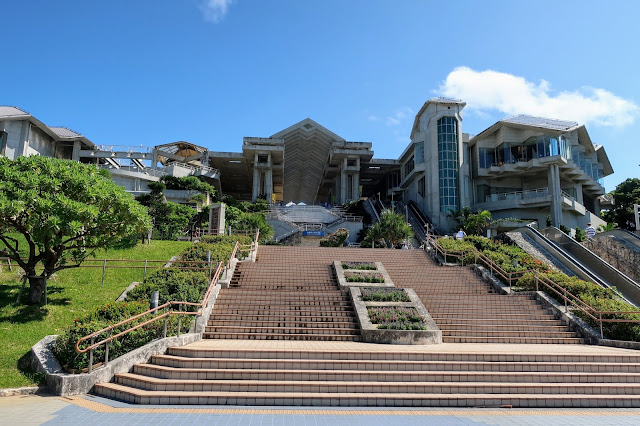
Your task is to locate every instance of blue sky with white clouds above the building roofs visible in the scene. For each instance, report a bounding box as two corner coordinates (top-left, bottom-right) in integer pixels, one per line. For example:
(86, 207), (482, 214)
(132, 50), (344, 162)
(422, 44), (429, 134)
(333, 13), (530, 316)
(0, 0), (640, 190)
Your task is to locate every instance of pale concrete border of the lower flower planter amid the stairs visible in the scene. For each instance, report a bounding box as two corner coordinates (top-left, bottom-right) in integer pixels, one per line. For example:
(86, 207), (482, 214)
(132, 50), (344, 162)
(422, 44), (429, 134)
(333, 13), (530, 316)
(349, 286), (442, 345)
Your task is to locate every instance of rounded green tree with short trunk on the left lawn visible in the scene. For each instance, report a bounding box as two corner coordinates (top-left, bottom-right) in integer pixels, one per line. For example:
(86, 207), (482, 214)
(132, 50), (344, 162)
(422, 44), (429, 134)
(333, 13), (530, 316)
(0, 156), (151, 303)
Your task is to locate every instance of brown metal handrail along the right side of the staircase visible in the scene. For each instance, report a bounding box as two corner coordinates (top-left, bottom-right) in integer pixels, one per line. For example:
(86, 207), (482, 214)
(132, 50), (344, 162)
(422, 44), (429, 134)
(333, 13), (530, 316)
(426, 234), (640, 339)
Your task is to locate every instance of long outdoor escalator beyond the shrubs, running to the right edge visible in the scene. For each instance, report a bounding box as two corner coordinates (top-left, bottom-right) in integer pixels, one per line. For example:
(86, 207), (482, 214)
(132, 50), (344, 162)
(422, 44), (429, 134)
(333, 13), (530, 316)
(515, 226), (640, 306)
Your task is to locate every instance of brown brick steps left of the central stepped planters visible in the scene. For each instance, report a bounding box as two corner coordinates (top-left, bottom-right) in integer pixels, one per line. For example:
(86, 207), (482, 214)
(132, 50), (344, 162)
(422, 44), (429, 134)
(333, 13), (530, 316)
(203, 261), (360, 341)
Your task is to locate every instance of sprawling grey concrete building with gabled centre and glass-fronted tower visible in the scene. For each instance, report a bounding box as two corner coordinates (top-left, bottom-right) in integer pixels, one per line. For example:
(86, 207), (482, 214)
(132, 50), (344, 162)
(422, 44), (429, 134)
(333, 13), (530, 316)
(0, 98), (613, 231)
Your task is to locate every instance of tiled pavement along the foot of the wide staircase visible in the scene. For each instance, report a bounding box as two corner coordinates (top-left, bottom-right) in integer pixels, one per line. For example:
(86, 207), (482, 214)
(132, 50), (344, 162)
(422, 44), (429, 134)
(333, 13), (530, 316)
(0, 396), (640, 426)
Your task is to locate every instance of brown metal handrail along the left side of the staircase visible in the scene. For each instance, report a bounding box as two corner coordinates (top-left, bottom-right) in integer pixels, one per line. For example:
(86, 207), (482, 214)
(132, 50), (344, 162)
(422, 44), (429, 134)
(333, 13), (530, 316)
(75, 229), (260, 373)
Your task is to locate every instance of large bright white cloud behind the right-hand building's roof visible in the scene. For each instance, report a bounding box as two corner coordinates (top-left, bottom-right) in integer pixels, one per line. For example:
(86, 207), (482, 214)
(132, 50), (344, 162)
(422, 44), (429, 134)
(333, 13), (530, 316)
(439, 67), (640, 127)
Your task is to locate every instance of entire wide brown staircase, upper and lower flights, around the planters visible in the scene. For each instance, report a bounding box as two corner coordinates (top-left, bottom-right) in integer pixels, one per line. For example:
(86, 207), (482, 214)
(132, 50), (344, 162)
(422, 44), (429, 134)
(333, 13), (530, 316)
(94, 246), (640, 407)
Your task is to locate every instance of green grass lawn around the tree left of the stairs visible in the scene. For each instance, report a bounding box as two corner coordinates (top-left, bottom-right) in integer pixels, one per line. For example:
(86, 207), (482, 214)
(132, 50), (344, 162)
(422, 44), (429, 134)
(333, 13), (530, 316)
(0, 241), (191, 388)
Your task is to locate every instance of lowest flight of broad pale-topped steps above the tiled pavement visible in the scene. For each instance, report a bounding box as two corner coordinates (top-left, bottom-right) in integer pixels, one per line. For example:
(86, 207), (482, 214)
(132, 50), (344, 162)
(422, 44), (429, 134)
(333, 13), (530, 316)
(95, 340), (640, 407)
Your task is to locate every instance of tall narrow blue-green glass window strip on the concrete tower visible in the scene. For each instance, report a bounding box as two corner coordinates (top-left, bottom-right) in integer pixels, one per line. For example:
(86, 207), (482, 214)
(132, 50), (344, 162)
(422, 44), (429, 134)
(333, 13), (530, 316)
(438, 117), (459, 213)
